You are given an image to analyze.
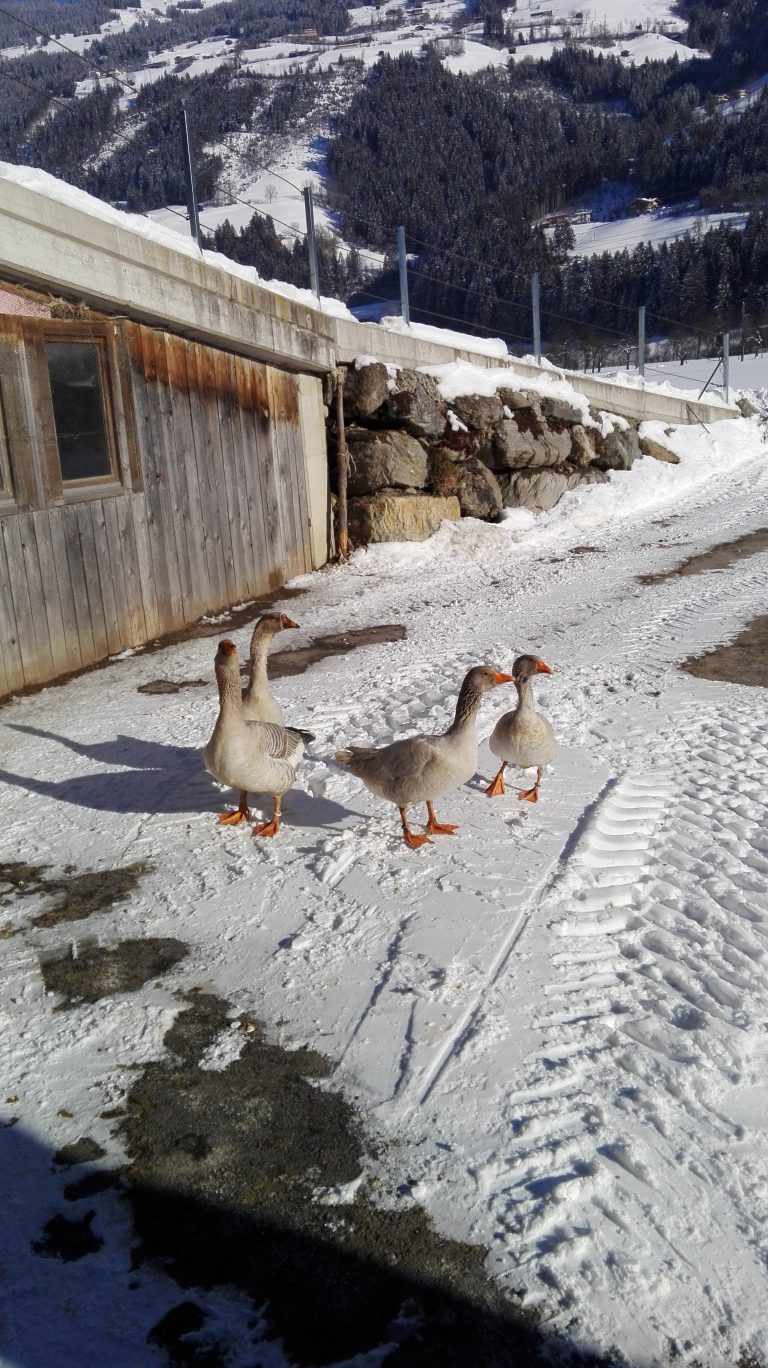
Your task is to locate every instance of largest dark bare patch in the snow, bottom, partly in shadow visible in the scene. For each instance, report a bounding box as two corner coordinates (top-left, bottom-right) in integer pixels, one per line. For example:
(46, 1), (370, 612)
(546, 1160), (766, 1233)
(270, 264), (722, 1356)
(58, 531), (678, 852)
(119, 993), (564, 1368)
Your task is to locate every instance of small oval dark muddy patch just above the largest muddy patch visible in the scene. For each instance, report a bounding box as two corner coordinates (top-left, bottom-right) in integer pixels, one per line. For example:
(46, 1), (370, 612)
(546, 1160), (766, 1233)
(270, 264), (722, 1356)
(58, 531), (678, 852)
(40, 936), (189, 1010)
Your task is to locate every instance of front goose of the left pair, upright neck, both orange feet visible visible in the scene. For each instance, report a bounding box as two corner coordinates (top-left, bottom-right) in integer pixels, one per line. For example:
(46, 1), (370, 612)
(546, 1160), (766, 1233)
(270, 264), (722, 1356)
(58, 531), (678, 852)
(203, 640), (315, 836)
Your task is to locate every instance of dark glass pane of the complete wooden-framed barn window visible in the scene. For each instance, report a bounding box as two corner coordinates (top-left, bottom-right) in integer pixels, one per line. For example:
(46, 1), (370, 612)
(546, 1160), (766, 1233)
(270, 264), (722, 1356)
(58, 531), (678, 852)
(45, 342), (112, 483)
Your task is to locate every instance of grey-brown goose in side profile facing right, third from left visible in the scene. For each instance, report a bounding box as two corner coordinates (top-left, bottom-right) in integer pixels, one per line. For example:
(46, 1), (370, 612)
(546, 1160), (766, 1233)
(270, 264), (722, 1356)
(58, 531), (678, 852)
(335, 665), (513, 850)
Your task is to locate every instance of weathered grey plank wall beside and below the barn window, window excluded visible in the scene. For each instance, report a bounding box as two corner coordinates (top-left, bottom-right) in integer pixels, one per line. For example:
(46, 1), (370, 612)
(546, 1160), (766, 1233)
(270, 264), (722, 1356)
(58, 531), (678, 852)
(0, 323), (320, 696)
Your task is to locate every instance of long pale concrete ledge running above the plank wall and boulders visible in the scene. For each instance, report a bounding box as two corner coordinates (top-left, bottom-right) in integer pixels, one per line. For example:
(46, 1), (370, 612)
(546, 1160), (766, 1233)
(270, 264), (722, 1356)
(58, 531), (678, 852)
(0, 173), (738, 424)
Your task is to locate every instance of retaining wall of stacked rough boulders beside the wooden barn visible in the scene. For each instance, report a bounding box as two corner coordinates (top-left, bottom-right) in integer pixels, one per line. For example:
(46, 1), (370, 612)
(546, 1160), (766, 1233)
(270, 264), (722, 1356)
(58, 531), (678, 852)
(335, 363), (678, 546)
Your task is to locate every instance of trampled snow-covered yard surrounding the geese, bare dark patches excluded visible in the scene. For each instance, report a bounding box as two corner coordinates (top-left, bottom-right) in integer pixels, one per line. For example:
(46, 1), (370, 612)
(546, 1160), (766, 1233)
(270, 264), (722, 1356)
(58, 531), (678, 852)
(0, 372), (768, 1368)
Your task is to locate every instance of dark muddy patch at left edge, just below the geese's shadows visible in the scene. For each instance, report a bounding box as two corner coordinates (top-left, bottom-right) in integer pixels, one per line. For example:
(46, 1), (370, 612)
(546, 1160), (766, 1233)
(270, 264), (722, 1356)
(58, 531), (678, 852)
(0, 860), (152, 926)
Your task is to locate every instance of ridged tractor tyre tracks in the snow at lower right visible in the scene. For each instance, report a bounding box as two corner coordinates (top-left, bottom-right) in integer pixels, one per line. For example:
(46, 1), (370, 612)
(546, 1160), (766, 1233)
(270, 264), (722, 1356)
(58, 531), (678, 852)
(489, 706), (768, 1361)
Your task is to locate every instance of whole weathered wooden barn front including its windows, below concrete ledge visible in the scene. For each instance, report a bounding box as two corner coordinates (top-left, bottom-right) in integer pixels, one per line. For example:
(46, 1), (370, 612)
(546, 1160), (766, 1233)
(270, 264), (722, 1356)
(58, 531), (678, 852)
(0, 278), (327, 696)
